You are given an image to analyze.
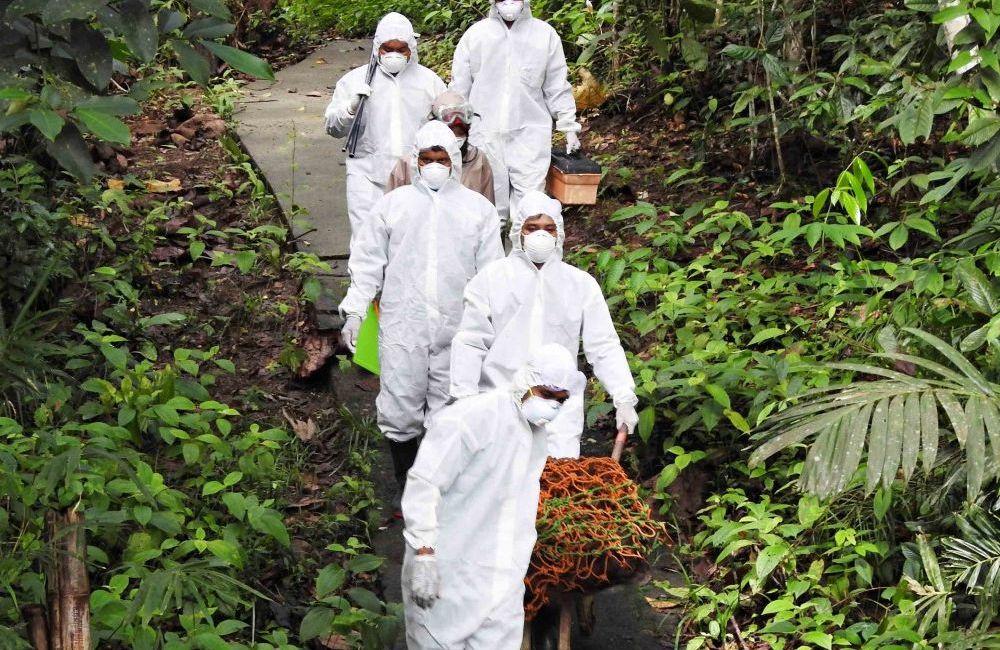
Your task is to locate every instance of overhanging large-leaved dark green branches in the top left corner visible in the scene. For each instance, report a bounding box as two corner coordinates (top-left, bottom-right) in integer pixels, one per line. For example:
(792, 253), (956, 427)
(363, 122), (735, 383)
(0, 0), (273, 181)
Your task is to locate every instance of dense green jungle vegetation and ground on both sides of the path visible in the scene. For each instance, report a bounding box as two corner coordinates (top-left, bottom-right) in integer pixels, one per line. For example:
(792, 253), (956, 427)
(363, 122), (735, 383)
(0, 0), (1000, 650)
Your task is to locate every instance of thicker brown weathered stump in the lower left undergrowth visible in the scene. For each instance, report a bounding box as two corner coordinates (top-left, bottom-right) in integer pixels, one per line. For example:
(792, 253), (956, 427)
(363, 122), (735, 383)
(47, 510), (90, 650)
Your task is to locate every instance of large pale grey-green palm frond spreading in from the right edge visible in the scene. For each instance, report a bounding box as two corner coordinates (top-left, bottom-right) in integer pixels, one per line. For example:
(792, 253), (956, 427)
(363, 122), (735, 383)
(750, 328), (1000, 500)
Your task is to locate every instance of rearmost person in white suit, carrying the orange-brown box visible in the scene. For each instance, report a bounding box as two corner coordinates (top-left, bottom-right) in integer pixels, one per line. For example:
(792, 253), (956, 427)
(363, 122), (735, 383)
(451, 0), (580, 218)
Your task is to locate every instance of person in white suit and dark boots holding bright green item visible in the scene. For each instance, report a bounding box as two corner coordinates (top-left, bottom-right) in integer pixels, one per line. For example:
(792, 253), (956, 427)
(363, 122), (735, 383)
(340, 122), (503, 496)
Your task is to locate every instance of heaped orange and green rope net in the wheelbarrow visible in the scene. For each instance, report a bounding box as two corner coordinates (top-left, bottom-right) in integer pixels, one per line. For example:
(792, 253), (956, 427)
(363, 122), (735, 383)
(524, 457), (666, 620)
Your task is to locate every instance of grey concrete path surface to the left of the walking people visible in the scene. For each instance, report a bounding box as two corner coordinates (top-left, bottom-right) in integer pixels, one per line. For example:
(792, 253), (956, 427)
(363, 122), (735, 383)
(236, 40), (371, 329)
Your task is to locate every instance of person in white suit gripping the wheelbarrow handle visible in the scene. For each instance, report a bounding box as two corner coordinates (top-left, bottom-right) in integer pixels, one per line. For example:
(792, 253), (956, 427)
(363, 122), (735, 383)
(450, 192), (639, 458)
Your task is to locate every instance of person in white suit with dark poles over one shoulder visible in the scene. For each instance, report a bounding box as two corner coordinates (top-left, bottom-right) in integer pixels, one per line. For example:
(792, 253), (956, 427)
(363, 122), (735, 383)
(326, 13), (445, 237)
